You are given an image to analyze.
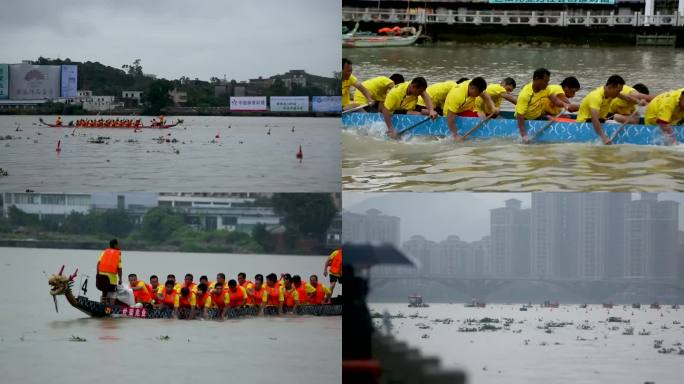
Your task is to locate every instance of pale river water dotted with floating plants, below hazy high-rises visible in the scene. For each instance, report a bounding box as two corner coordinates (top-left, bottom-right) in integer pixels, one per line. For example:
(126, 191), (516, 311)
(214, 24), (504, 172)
(369, 303), (684, 384)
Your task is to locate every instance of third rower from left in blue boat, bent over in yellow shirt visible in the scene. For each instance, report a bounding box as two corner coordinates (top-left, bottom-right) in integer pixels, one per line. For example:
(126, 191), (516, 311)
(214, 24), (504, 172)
(380, 77), (437, 139)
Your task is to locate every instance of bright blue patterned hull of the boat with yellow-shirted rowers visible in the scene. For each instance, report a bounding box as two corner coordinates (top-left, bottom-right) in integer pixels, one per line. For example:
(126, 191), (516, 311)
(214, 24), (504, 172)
(342, 112), (684, 145)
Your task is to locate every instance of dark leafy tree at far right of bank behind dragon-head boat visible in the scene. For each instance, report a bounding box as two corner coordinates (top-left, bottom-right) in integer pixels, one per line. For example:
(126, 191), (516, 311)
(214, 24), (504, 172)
(272, 193), (337, 239)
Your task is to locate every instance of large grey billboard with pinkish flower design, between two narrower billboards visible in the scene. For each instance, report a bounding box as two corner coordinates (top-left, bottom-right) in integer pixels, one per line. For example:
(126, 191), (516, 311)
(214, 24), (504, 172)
(9, 64), (61, 100)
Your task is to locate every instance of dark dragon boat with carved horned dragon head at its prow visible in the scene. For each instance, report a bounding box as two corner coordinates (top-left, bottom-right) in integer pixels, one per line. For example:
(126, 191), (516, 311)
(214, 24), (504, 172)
(48, 267), (342, 319)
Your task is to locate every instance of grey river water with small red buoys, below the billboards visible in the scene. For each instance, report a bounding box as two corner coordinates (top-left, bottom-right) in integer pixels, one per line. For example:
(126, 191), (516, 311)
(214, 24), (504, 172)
(0, 116), (340, 192)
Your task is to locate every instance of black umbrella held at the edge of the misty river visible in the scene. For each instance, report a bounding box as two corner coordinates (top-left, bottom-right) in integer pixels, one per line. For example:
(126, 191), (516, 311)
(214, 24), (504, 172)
(342, 244), (420, 268)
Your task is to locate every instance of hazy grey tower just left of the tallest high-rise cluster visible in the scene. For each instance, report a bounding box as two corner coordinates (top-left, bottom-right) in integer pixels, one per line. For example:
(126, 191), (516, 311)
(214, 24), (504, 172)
(490, 199), (530, 277)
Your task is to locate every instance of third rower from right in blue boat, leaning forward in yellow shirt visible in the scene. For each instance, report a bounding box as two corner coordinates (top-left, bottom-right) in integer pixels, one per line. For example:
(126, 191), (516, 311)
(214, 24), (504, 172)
(577, 75), (629, 145)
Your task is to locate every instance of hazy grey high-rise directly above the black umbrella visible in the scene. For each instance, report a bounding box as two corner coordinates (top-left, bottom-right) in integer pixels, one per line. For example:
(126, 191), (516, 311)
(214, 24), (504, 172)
(342, 209), (400, 247)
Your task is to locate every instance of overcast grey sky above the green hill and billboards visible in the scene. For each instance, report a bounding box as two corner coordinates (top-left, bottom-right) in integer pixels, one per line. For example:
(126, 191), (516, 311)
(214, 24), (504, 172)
(0, 0), (342, 80)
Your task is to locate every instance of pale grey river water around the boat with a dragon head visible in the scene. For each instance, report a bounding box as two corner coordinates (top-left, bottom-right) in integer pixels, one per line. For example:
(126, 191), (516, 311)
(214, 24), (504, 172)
(0, 248), (342, 384)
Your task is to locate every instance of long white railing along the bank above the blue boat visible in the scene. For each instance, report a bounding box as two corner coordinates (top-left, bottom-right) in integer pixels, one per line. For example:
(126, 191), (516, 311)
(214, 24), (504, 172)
(342, 8), (684, 27)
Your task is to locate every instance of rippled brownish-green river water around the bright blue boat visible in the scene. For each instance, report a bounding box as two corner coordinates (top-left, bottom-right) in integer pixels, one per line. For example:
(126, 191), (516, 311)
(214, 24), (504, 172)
(342, 44), (684, 191)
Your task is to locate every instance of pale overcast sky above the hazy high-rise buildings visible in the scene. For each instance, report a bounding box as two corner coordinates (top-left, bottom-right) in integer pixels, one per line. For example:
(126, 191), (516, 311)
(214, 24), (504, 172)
(342, 192), (684, 241)
